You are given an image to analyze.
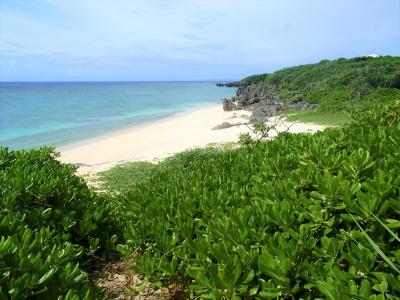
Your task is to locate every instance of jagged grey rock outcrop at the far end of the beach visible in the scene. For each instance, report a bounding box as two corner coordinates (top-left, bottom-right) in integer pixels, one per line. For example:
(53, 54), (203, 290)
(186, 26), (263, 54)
(223, 84), (317, 122)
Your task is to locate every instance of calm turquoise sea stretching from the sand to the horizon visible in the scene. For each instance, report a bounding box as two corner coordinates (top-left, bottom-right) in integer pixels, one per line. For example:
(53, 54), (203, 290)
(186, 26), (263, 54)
(0, 82), (235, 149)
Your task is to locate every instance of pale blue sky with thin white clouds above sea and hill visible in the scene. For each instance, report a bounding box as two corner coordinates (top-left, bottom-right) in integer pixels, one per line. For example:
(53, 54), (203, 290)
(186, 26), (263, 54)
(0, 0), (400, 81)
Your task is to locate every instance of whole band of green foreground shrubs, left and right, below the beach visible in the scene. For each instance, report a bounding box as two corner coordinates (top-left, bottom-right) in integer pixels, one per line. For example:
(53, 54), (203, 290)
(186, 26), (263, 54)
(0, 55), (400, 299)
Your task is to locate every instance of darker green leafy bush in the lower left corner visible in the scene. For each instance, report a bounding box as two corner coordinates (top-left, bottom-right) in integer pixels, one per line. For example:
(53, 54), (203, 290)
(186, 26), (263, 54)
(0, 148), (121, 299)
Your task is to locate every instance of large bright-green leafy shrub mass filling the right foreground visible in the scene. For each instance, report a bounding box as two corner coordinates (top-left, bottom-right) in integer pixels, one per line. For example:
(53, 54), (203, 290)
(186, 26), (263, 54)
(119, 103), (400, 299)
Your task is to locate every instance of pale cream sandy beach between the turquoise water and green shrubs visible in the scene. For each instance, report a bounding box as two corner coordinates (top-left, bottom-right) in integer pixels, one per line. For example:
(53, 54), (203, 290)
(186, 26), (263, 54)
(58, 105), (325, 174)
